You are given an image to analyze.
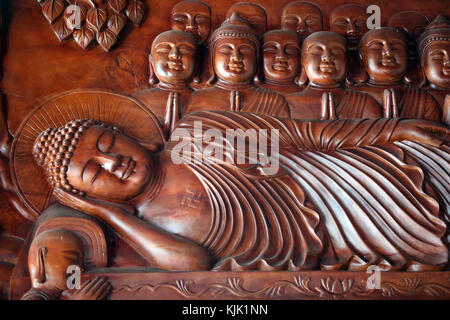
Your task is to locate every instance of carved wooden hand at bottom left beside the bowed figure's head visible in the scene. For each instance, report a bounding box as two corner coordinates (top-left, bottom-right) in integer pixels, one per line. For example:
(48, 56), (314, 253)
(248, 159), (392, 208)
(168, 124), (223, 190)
(61, 277), (112, 300)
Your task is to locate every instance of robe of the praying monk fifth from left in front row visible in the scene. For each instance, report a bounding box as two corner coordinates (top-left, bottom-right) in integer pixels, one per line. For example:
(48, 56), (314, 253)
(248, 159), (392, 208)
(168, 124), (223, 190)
(354, 84), (442, 122)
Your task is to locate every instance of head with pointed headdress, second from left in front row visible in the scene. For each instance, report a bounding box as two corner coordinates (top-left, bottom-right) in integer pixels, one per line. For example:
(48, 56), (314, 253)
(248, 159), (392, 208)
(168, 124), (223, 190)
(209, 13), (260, 83)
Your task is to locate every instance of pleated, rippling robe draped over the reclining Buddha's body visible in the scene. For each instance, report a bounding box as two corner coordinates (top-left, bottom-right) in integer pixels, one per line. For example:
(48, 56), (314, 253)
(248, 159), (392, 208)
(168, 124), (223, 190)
(165, 112), (448, 271)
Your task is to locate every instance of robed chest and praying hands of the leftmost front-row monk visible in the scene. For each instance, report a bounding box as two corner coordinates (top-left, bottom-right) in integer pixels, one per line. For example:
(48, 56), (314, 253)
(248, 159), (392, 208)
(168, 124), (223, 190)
(133, 88), (193, 137)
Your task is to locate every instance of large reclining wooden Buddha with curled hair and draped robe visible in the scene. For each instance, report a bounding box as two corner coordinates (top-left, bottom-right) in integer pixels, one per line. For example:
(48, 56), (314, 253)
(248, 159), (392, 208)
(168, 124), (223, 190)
(33, 111), (449, 271)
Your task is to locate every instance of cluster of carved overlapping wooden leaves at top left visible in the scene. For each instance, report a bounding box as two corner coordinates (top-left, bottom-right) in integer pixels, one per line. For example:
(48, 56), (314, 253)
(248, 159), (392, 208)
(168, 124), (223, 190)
(37, 0), (145, 52)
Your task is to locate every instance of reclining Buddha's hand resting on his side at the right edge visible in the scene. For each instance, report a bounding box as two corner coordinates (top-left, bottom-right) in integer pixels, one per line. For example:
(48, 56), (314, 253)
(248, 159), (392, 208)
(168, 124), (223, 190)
(389, 119), (450, 147)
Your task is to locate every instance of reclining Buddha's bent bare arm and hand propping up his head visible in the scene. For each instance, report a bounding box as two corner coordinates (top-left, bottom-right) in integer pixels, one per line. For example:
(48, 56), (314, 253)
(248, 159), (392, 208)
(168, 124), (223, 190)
(55, 189), (212, 271)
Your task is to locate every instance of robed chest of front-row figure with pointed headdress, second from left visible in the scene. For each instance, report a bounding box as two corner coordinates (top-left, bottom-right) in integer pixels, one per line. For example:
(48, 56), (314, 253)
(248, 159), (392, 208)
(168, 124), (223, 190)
(184, 84), (290, 118)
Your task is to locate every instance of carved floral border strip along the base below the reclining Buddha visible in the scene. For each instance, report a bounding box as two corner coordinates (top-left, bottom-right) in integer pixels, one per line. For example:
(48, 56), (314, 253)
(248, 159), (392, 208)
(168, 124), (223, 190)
(113, 276), (450, 299)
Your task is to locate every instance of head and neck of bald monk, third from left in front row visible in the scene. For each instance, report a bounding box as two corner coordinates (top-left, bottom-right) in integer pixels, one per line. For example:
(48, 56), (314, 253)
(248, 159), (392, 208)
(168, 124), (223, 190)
(260, 30), (301, 96)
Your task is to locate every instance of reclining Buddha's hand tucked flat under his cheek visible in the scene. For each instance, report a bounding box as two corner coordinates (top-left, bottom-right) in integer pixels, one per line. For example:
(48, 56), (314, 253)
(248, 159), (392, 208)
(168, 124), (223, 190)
(53, 188), (134, 220)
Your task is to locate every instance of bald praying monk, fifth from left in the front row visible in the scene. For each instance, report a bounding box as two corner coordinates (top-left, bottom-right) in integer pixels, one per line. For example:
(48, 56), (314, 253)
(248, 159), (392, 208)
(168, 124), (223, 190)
(355, 28), (442, 122)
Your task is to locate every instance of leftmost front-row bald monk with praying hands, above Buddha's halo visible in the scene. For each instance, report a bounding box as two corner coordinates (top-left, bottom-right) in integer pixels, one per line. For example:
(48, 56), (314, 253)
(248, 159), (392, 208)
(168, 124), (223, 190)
(134, 30), (197, 137)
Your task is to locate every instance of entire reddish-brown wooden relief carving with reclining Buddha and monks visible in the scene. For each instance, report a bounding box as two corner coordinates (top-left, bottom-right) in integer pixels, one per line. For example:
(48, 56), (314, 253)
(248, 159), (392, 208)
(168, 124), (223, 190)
(0, 0), (450, 300)
